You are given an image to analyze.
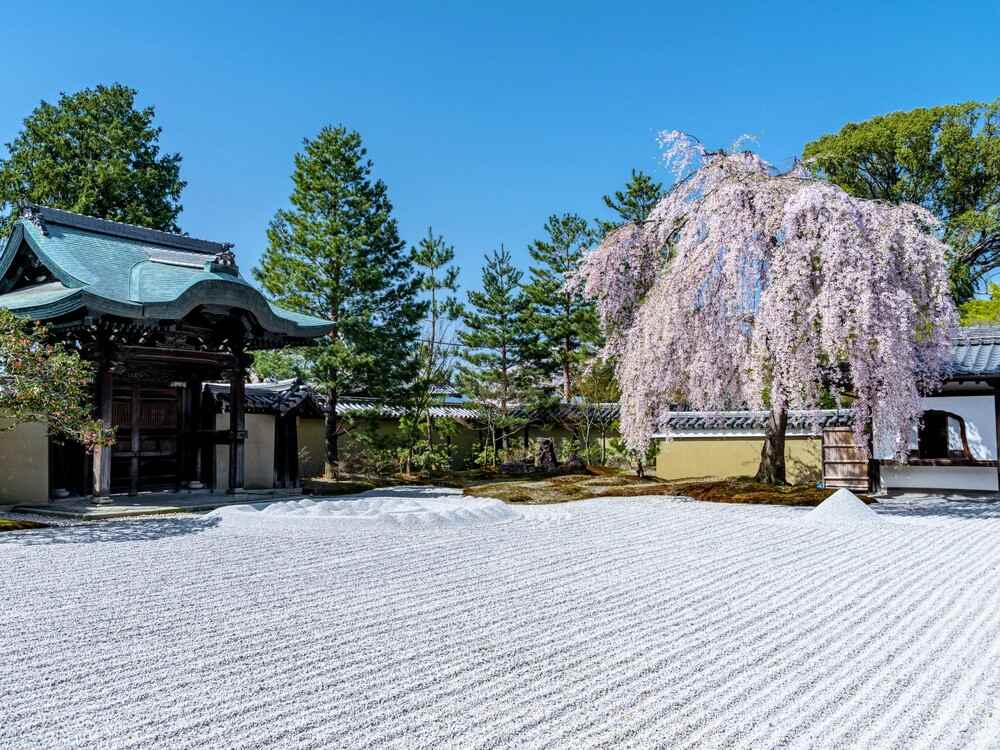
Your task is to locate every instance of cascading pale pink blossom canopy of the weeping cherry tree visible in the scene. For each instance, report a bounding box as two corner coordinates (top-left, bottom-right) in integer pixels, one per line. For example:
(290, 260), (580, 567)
(571, 138), (955, 456)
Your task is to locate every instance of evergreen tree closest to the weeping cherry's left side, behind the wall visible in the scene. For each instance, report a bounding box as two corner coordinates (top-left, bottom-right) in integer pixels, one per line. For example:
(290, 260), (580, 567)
(524, 214), (601, 401)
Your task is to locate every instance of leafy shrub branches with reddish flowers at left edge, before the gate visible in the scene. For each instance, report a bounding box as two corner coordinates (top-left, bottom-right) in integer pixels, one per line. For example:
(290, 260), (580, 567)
(0, 308), (114, 450)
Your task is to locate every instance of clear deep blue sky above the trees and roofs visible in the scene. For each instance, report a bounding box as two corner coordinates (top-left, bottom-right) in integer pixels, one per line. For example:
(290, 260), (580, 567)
(0, 0), (1000, 296)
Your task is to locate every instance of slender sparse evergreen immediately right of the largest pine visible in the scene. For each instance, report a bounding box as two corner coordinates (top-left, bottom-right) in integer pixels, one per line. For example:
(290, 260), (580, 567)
(413, 227), (462, 445)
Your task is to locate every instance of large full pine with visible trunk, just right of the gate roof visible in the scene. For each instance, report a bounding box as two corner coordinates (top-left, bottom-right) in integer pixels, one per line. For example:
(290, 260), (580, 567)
(254, 122), (427, 476)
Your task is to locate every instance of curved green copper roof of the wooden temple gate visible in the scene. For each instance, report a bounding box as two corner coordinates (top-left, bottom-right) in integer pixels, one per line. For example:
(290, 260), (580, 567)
(0, 207), (332, 338)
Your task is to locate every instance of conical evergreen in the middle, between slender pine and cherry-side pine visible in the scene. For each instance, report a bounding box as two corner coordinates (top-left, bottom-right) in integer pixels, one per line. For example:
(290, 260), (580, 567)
(458, 246), (545, 467)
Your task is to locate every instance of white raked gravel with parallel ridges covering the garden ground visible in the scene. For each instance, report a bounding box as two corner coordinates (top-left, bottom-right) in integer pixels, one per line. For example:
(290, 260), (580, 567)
(0, 488), (1000, 750)
